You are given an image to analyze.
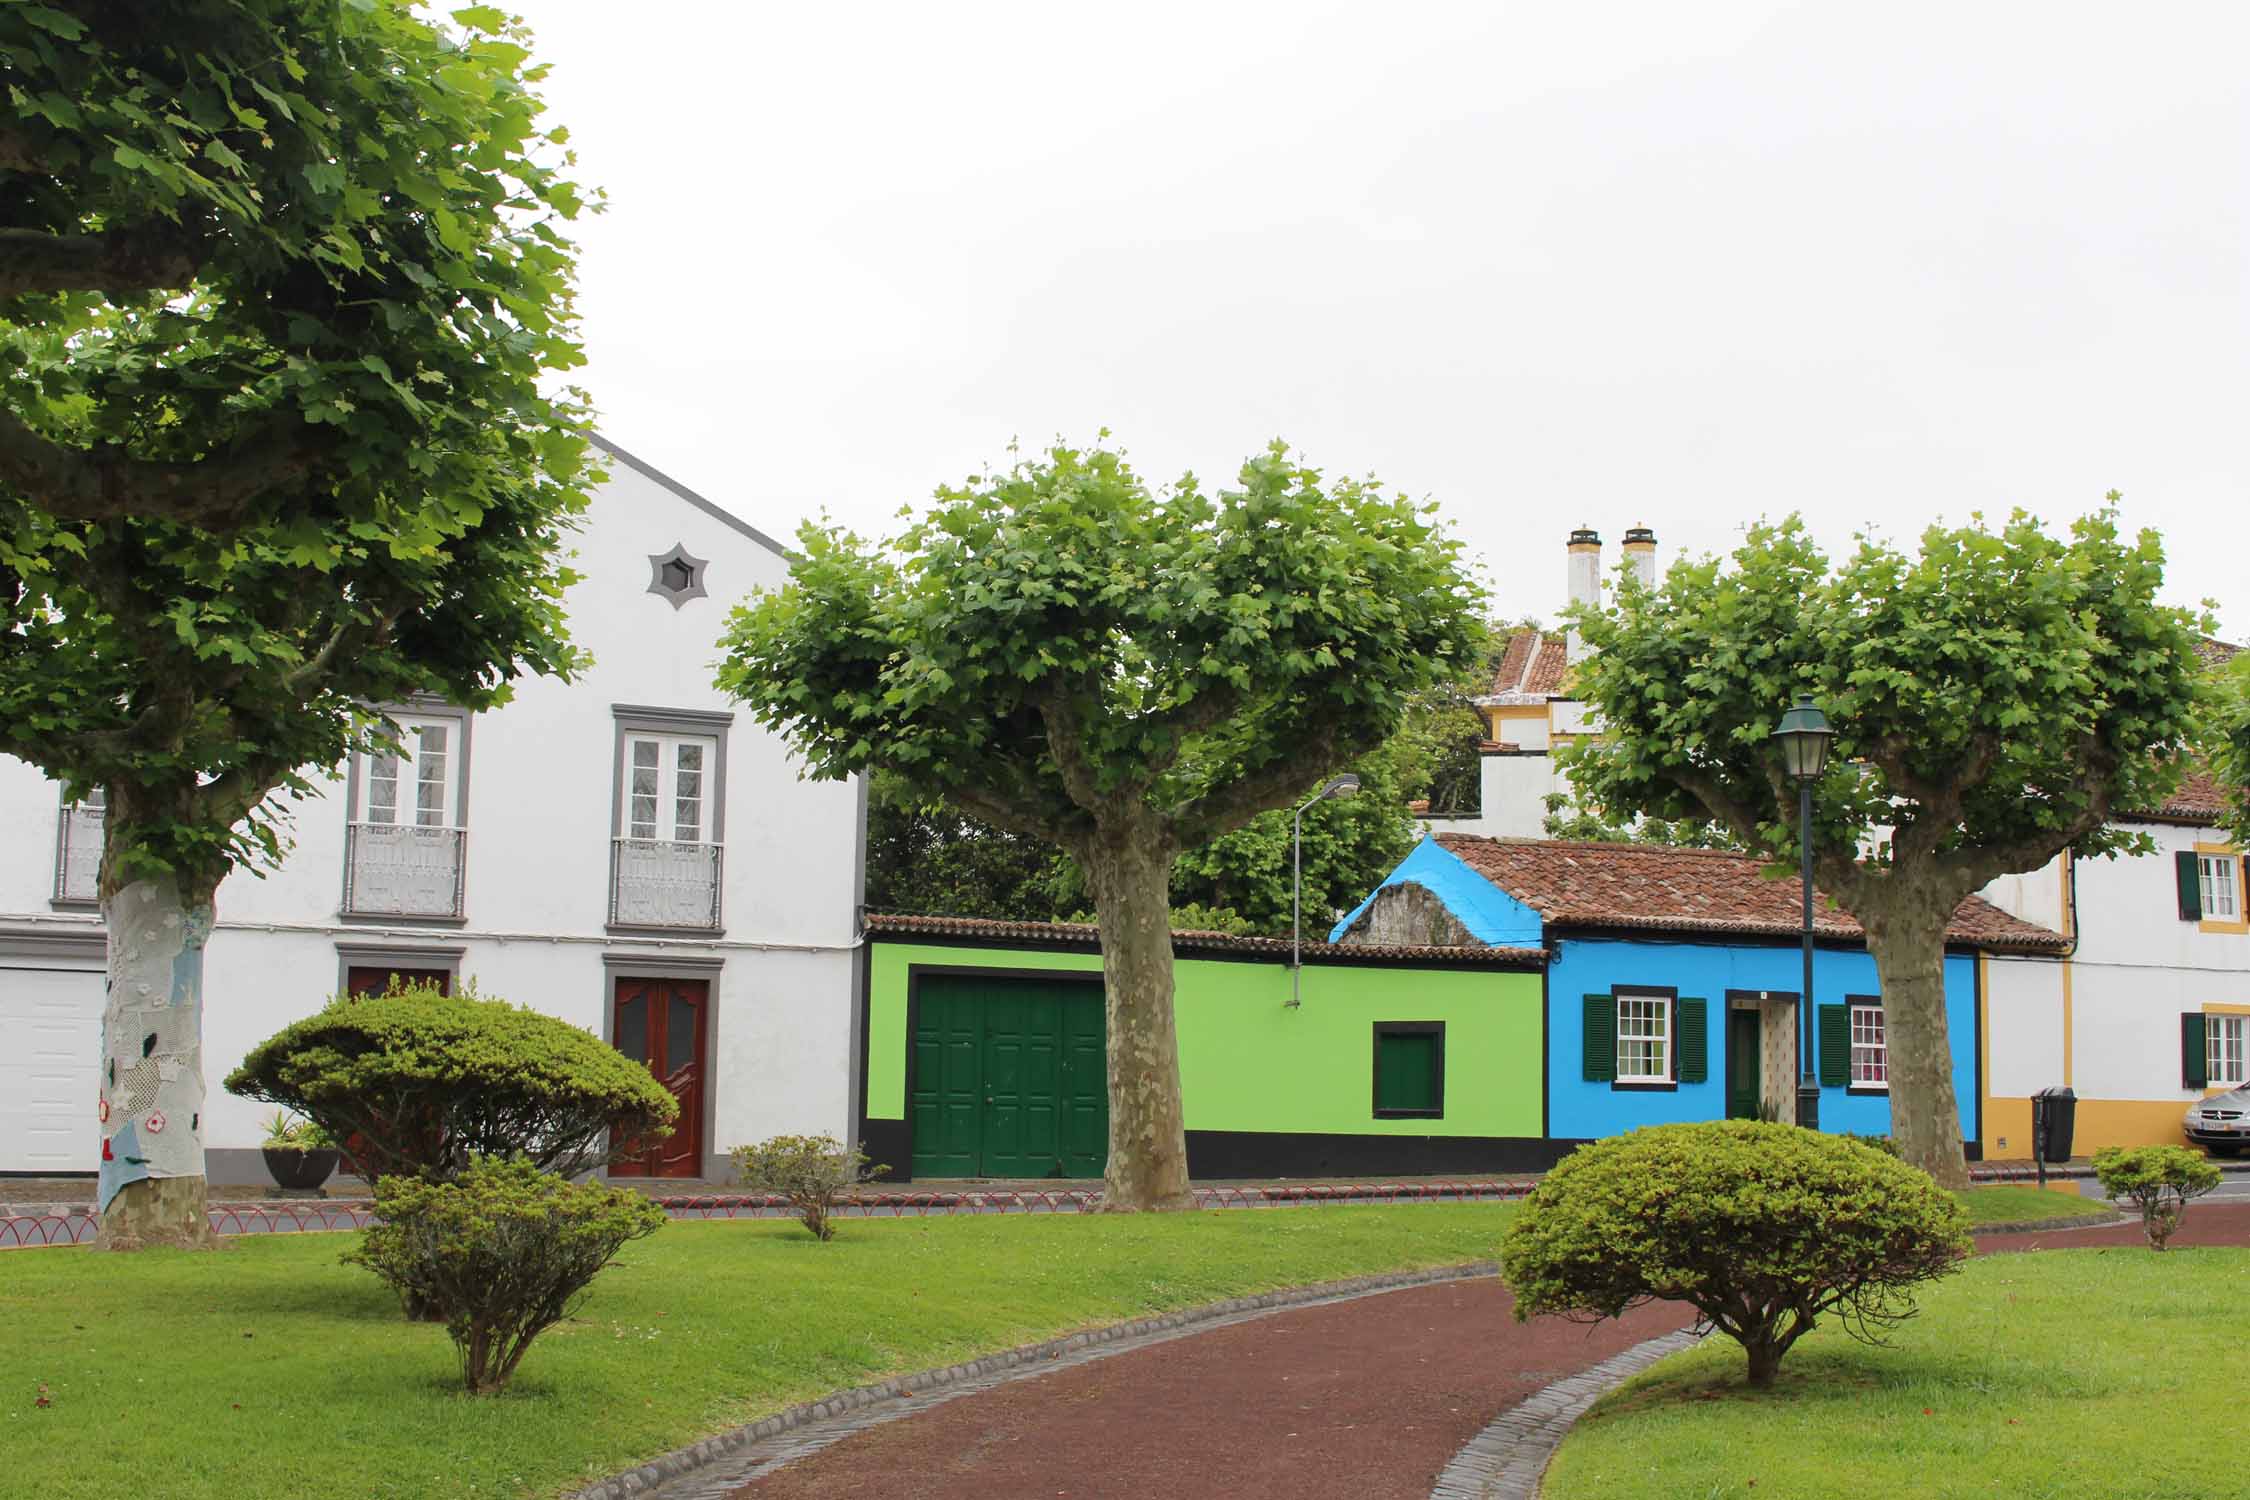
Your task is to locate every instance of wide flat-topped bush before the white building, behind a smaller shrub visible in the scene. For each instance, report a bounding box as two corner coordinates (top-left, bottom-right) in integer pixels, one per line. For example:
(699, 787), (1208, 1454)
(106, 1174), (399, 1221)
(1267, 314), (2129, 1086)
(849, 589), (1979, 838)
(227, 985), (680, 1181)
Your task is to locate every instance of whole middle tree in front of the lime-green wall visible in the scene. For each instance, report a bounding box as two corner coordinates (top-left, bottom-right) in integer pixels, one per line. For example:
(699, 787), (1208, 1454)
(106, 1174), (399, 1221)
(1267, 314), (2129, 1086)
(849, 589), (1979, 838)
(720, 443), (1478, 1208)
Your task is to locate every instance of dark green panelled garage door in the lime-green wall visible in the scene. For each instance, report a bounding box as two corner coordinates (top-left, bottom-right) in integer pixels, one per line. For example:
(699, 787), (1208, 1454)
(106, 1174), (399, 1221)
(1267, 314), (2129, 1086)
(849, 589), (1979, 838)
(911, 976), (1109, 1176)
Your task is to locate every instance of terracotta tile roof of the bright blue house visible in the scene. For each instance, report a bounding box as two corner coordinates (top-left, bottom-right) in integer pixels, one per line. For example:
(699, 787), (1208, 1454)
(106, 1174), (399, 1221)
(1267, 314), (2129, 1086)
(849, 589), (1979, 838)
(1438, 834), (2063, 954)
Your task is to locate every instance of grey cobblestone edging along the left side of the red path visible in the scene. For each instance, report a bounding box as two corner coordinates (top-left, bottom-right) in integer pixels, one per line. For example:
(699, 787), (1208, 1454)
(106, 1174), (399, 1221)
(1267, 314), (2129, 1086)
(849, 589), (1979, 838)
(565, 1259), (1499, 1500)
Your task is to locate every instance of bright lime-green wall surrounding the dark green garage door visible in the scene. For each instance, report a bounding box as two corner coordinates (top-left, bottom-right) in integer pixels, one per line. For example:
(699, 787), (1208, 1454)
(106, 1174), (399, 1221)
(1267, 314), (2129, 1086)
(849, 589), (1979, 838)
(866, 940), (1541, 1136)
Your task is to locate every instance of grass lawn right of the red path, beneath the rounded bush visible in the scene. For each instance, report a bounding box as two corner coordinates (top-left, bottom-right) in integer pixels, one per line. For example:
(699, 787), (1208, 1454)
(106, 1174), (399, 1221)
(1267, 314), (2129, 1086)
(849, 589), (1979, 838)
(1546, 1246), (2250, 1500)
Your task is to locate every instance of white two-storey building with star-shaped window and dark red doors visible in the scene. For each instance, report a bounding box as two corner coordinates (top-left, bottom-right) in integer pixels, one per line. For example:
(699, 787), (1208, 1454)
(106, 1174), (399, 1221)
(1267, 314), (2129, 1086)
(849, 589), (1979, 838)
(0, 443), (866, 1183)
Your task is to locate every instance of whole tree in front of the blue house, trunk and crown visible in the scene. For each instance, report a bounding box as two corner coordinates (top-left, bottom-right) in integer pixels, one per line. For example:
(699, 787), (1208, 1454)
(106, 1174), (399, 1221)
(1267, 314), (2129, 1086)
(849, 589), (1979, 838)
(1571, 510), (2201, 1185)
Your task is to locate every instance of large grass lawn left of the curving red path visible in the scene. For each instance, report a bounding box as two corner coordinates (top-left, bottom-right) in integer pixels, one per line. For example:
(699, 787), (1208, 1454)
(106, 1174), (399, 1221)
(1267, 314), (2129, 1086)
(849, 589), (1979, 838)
(0, 1203), (1514, 1500)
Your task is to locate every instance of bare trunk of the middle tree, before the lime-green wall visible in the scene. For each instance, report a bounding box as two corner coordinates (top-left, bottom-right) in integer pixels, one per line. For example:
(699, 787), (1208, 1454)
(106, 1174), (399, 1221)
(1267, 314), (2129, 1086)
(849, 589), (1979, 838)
(1087, 823), (1195, 1212)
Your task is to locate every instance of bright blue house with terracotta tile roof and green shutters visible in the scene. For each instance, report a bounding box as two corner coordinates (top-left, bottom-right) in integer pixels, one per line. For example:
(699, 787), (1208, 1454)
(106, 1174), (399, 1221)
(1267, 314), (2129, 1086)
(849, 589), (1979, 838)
(1330, 834), (2063, 1156)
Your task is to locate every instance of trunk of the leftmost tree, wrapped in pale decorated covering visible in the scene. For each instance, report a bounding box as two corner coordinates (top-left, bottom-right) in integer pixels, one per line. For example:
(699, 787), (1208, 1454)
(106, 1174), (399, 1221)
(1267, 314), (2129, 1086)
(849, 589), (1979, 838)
(97, 872), (216, 1250)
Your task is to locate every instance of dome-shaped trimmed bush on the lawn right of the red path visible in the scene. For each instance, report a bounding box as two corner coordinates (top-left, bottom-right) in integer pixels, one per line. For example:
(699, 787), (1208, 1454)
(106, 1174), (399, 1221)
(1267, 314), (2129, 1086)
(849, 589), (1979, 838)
(1501, 1120), (1969, 1388)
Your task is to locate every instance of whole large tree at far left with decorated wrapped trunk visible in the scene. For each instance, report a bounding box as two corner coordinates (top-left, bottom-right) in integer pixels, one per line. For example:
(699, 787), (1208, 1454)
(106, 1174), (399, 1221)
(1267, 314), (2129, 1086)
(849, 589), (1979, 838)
(0, 0), (594, 1244)
